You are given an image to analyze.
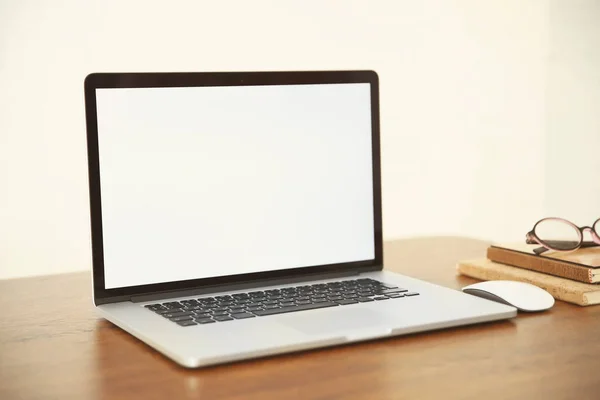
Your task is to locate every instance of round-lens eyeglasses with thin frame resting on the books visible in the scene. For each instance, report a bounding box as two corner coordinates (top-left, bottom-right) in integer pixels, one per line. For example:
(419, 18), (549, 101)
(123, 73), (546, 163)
(526, 218), (600, 254)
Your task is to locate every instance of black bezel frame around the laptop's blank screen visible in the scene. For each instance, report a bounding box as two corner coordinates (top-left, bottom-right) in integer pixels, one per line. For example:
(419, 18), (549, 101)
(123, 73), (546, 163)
(84, 70), (383, 304)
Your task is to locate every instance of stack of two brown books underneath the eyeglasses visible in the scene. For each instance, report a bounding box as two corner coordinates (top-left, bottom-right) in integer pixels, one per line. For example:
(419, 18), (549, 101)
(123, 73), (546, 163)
(457, 243), (600, 306)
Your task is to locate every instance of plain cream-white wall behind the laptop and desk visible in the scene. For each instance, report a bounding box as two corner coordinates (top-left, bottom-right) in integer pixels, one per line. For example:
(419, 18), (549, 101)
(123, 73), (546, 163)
(0, 0), (600, 278)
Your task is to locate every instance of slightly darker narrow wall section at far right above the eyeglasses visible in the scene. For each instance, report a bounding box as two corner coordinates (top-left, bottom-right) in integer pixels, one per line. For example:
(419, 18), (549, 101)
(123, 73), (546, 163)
(543, 0), (600, 225)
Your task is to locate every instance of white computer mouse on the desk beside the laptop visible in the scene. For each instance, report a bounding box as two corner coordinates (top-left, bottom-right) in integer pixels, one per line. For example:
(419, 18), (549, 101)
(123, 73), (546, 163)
(462, 281), (554, 312)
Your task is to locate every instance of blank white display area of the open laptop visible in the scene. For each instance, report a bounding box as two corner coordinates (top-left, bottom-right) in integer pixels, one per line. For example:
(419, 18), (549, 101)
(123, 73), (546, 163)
(96, 83), (375, 289)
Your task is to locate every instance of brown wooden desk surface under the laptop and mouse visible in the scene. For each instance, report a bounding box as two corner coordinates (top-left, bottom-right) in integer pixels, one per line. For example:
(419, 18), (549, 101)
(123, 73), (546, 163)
(0, 238), (600, 400)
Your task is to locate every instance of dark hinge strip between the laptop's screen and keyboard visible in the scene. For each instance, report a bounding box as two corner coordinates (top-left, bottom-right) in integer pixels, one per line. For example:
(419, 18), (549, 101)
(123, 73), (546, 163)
(130, 269), (365, 303)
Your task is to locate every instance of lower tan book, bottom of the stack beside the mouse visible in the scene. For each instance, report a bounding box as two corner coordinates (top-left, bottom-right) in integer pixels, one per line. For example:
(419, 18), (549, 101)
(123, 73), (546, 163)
(456, 258), (600, 306)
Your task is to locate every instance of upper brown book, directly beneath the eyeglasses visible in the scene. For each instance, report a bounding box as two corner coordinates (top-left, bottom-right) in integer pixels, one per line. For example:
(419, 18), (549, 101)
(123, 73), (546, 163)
(487, 243), (600, 283)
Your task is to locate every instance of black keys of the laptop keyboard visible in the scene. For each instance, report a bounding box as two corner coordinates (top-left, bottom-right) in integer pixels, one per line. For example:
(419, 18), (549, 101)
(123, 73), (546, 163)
(145, 278), (418, 326)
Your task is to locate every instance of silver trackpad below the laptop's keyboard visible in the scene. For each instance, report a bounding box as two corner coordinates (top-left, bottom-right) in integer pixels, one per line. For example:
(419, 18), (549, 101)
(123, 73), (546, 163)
(278, 308), (391, 335)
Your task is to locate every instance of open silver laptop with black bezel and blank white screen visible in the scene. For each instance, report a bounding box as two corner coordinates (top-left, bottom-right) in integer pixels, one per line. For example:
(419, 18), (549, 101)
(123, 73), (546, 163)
(84, 71), (516, 368)
